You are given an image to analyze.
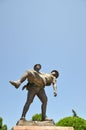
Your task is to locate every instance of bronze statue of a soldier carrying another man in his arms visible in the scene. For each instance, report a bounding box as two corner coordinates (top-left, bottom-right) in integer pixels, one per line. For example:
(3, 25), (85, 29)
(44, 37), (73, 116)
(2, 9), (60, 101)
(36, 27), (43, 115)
(9, 64), (59, 121)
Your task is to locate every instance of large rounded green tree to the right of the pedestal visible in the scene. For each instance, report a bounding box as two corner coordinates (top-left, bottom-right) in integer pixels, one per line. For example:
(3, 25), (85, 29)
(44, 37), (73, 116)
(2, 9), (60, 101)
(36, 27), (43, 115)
(56, 116), (86, 130)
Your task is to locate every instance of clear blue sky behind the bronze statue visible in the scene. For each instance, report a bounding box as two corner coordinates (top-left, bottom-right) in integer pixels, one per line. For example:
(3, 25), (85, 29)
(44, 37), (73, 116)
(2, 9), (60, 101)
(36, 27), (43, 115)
(0, 0), (86, 129)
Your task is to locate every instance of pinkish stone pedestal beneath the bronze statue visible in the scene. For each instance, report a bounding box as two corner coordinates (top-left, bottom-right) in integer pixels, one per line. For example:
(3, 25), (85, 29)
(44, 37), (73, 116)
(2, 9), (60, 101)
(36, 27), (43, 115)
(11, 120), (74, 130)
